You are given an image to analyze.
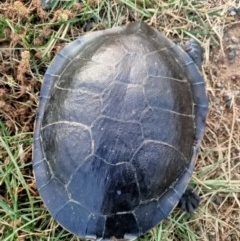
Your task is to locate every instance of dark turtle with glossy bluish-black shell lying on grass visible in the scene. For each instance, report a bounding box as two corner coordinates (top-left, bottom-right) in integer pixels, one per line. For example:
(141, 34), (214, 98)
(33, 21), (208, 240)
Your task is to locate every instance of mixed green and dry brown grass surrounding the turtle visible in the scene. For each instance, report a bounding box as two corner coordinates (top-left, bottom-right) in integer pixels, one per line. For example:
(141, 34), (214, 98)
(0, 0), (240, 241)
